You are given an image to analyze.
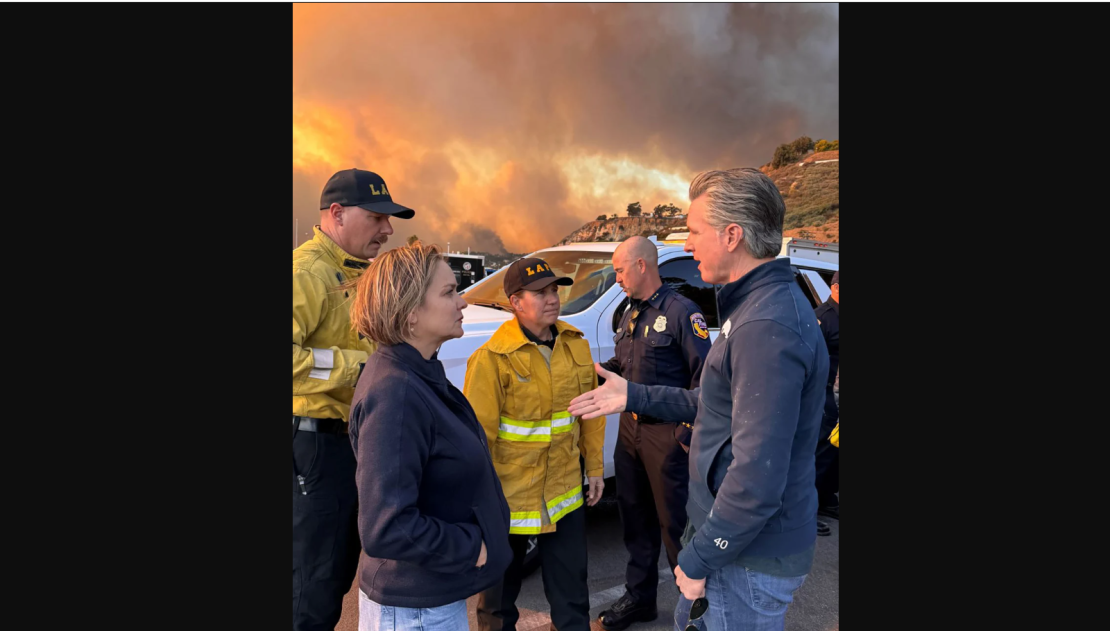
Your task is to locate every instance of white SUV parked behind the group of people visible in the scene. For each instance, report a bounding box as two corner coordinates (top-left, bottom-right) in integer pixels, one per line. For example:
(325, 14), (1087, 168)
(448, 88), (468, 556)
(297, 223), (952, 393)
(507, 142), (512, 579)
(440, 243), (839, 478)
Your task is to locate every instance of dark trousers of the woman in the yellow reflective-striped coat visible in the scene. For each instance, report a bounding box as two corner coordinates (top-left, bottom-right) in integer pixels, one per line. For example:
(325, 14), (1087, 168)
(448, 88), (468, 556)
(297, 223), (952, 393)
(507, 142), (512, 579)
(477, 505), (589, 631)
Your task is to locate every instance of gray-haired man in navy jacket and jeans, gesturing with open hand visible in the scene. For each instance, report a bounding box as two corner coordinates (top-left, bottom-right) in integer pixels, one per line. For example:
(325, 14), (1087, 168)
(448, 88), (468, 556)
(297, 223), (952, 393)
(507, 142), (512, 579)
(568, 169), (829, 631)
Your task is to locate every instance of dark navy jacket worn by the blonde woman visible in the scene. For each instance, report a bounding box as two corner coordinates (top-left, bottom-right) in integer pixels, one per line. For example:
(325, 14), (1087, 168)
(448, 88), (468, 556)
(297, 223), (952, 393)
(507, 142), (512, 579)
(350, 343), (513, 608)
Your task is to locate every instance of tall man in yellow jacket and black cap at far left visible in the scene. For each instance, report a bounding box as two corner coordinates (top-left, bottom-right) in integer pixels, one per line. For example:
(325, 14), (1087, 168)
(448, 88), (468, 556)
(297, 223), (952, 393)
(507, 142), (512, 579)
(292, 169), (415, 631)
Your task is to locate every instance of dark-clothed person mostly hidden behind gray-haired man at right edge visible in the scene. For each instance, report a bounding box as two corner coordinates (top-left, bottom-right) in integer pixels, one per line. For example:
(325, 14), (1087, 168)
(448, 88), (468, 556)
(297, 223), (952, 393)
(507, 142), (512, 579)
(815, 271), (840, 519)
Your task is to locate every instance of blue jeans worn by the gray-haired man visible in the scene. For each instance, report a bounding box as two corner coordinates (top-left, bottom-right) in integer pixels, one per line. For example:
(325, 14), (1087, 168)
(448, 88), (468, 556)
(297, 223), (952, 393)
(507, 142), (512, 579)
(675, 564), (806, 631)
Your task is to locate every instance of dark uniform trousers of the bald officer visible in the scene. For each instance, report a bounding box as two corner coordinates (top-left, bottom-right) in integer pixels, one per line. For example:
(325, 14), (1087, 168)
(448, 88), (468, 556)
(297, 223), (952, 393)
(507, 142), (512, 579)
(613, 413), (689, 604)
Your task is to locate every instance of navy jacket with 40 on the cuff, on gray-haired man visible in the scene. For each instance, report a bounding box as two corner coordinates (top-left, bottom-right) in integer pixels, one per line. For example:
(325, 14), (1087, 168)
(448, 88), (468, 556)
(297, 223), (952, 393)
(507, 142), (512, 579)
(627, 260), (829, 579)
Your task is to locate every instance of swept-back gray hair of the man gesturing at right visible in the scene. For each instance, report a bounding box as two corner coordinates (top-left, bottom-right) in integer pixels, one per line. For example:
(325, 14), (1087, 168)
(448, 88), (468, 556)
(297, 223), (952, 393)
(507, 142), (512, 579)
(689, 168), (786, 259)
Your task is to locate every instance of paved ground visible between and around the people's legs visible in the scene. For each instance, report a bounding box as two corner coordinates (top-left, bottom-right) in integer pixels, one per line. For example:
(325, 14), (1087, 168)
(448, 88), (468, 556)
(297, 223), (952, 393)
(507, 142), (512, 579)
(336, 498), (840, 631)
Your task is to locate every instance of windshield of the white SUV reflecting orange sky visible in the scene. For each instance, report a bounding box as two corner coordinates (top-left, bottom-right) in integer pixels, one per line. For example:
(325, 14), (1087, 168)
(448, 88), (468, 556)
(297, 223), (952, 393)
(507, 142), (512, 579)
(463, 250), (617, 316)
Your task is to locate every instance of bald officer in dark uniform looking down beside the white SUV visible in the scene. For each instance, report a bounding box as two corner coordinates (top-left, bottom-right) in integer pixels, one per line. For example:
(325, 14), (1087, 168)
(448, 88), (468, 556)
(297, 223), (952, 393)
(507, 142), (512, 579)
(601, 237), (712, 631)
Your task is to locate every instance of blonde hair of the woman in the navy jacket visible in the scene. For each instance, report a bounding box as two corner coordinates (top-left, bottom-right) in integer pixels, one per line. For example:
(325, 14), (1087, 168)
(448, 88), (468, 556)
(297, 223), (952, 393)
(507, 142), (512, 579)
(351, 241), (444, 345)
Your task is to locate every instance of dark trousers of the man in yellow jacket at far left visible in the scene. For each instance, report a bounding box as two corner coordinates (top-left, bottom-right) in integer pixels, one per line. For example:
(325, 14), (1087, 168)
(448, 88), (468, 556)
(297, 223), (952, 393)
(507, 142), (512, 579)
(292, 431), (362, 631)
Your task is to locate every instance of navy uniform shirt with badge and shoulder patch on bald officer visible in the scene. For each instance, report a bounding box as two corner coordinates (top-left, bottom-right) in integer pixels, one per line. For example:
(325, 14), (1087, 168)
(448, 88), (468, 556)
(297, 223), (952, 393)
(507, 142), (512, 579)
(602, 283), (710, 447)
